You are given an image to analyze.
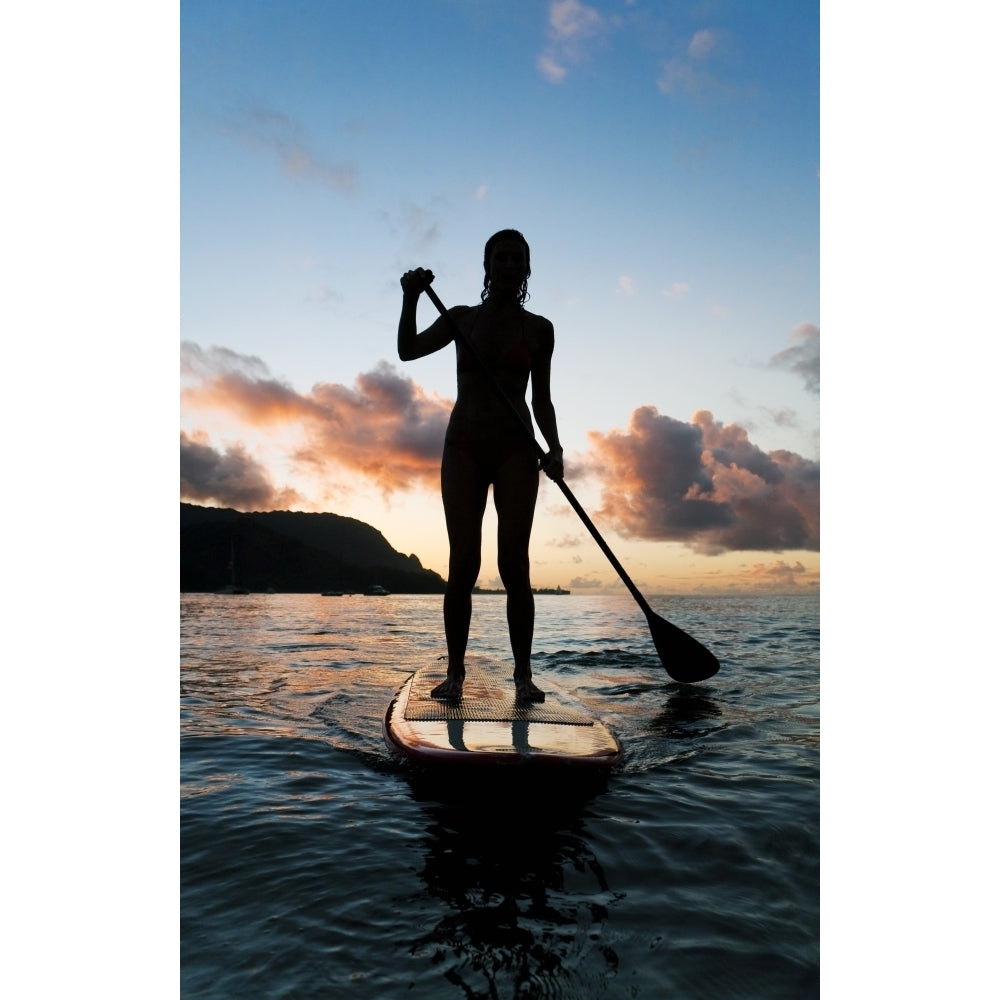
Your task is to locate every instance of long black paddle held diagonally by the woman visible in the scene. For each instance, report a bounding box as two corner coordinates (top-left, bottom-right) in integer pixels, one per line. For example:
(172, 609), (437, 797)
(424, 285), (719, 683)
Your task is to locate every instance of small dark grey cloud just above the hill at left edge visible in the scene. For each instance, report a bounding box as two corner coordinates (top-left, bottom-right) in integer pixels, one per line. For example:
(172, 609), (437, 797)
(181, 431), (302, 510)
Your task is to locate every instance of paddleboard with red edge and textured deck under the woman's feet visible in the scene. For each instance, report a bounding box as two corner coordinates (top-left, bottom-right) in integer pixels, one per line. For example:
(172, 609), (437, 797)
(382, 656), (621, 768)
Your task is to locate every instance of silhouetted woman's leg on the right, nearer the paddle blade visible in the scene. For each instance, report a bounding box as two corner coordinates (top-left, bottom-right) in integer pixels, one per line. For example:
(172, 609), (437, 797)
(493, 449), (545, 701)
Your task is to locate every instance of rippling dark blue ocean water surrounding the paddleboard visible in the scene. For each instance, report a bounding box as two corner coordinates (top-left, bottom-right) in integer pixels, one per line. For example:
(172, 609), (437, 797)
(180, 594), (820, 1000)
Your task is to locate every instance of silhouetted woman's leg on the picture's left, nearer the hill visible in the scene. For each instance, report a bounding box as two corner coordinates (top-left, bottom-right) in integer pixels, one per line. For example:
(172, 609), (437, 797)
(431, 444), (489, 698)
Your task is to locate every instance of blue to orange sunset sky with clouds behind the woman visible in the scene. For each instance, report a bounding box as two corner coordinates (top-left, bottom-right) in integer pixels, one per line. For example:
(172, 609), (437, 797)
(180, 0), (820, 593)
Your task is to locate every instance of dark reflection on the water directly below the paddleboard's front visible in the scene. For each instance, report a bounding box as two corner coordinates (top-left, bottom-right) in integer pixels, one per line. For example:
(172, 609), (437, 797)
(411, 770), (618, 997)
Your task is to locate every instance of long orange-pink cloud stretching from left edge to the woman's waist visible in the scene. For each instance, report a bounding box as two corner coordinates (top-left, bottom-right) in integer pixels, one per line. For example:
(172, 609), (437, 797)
(181, 344), (452, 504)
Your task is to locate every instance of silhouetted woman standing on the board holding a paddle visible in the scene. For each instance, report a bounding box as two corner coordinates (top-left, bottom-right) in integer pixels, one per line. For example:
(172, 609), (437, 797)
(397, 229), (563, 701)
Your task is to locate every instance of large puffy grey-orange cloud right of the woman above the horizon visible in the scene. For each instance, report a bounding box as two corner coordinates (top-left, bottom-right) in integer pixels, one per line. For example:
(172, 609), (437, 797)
(589, 406), (819, 555)
